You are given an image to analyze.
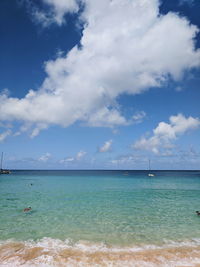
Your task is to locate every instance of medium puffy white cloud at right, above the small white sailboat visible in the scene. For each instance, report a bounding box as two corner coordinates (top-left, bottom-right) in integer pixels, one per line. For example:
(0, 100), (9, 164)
(133, 114), (200, 153)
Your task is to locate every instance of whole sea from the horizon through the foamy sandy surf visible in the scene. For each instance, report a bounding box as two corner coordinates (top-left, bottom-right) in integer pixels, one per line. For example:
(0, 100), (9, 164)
(0, 170), (200, 267)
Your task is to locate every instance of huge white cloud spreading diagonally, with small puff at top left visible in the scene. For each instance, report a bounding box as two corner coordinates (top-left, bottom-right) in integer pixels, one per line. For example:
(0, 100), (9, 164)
(0, 0), (200, 136)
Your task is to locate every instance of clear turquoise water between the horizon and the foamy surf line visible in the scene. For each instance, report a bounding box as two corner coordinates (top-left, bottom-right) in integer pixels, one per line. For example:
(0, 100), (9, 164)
(0, 171), (200, 246)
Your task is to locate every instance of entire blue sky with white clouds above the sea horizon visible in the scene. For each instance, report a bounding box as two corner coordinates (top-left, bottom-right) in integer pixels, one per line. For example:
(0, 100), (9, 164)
(0, 0), (200, 170)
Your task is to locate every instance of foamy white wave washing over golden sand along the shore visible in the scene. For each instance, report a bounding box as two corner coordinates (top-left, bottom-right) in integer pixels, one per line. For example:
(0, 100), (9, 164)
(0, 238), (200, 267)
